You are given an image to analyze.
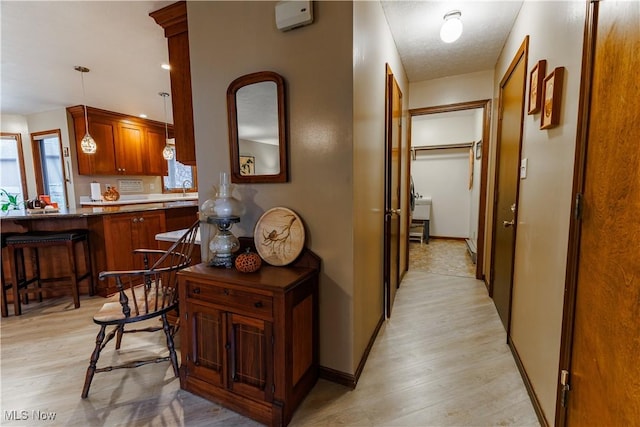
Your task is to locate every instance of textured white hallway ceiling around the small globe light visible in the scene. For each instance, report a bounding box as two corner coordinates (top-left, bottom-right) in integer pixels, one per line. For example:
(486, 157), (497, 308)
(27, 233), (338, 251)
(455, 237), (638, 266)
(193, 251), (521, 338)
(381, 1), (522, 82)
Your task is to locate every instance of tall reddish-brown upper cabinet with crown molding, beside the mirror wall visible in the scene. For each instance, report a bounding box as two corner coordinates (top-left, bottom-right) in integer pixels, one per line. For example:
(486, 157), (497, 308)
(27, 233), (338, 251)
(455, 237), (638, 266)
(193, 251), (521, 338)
(149, 1), (196, 166)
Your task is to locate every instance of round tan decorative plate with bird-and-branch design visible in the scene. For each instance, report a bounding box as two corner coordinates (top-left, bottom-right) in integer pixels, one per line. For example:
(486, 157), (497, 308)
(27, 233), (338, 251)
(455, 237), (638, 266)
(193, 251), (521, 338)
(253, 207), (305, 266)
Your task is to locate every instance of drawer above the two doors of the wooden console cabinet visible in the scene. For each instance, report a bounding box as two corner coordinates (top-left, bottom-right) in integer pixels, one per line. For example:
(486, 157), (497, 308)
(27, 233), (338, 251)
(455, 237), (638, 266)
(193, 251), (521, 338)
(186, 281), (273, 317)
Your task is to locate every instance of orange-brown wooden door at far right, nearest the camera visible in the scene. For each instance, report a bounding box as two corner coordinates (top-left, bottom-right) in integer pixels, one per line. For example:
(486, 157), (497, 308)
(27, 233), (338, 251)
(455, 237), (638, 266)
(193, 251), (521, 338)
(557, 0), (640, 426)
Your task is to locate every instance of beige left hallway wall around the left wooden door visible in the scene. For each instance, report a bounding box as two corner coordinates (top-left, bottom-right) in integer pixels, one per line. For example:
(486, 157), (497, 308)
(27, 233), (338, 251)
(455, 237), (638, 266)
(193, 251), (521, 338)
(353, 1), (409, 372)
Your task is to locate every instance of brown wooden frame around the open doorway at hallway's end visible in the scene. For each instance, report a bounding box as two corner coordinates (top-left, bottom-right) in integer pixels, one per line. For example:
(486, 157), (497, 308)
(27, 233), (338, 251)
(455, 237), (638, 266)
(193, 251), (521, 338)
(403, 99), (491, 285)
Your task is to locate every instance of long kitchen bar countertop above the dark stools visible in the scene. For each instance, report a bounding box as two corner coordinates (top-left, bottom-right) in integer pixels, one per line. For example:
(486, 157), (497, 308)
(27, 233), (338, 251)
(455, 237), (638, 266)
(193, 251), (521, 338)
(0, 200), (198, 221)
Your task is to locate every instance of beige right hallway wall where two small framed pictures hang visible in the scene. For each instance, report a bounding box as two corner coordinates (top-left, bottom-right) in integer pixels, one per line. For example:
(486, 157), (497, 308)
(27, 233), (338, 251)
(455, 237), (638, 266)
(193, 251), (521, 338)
(494, 2), (586, 424)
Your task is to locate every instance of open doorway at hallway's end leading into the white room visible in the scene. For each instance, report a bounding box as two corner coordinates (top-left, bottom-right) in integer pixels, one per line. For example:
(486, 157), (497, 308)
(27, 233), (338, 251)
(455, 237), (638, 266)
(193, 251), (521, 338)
(406, 99), (491, 280)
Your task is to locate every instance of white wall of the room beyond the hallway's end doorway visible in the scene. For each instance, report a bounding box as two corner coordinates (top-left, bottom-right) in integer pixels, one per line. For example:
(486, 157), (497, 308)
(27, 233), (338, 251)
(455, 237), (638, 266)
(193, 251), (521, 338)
(411, 109), (482, 238)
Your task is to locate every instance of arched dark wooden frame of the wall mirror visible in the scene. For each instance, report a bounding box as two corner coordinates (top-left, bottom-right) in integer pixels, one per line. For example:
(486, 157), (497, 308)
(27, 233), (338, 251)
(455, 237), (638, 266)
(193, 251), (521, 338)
(227, 71), (289, 184)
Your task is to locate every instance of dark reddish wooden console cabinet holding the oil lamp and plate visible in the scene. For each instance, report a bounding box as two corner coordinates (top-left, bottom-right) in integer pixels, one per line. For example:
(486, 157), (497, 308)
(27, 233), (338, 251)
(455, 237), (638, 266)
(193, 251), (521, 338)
(179, 251), (320, 426)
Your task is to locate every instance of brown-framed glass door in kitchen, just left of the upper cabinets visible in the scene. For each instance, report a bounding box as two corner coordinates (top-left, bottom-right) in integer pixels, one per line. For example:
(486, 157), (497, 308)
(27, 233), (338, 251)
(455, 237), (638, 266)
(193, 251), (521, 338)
(31, 129), (68, 207)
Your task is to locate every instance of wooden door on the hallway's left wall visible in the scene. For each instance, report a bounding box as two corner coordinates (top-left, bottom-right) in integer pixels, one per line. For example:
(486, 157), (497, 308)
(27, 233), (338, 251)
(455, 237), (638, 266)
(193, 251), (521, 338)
(384, 66), (402, 317)
